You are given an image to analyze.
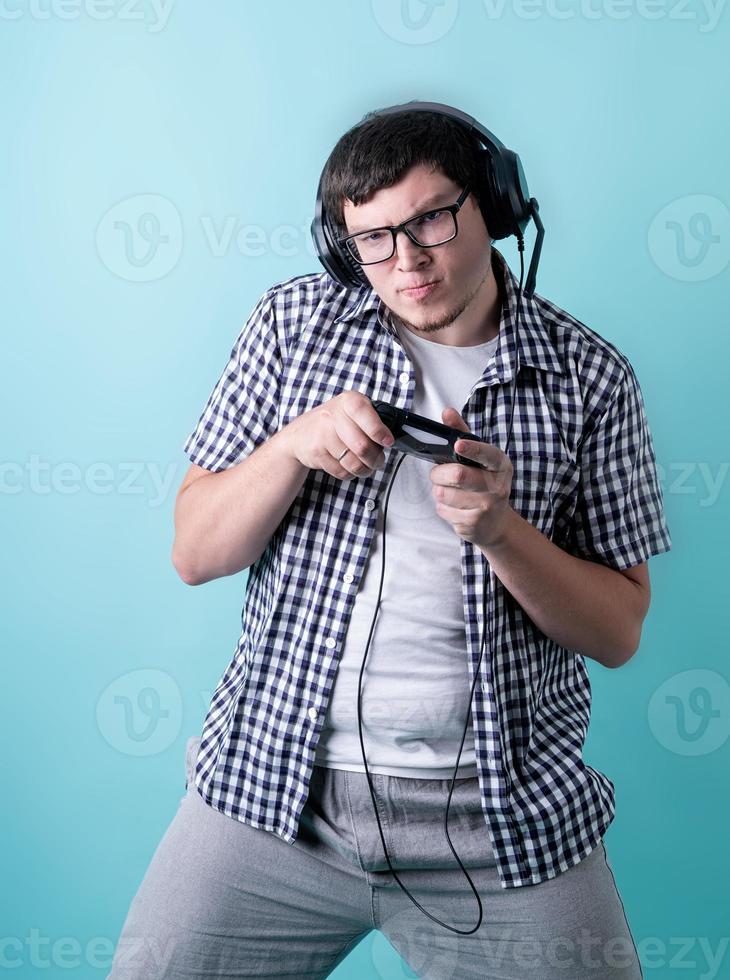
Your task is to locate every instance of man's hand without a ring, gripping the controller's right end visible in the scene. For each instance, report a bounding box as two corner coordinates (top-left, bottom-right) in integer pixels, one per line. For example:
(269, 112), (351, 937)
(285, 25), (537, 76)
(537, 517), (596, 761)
(430, 408), (513, 548)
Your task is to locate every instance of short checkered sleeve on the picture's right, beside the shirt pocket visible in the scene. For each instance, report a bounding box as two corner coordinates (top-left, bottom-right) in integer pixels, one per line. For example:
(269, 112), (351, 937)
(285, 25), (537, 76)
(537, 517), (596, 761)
(571, 364), (672, 570)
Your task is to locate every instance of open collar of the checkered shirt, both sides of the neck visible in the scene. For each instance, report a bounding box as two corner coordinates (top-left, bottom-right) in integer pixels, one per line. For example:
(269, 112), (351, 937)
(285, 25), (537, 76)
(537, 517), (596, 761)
(335, 246), (565, 381)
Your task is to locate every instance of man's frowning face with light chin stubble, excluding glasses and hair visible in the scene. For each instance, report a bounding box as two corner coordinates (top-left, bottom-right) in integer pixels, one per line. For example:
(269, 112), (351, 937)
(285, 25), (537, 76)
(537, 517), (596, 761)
(344, 164), (497, 344)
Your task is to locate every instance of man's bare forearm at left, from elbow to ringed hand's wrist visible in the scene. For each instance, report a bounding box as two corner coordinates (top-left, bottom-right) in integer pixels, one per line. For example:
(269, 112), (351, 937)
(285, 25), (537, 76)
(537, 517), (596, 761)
(173, 426), (309, 585)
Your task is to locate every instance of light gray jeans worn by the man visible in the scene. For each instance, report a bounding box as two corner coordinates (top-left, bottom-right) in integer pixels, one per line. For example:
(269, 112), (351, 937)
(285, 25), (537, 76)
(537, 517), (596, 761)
(107, 737), (642, 980)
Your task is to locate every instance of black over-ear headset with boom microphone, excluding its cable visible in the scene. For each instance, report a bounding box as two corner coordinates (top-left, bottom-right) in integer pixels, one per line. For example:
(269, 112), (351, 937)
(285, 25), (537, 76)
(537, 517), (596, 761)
(311, 102), (544, 296)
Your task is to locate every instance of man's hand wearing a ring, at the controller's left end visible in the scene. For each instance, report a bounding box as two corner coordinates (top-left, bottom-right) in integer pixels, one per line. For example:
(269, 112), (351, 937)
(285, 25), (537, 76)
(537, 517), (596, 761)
(285, 391), (393, 480)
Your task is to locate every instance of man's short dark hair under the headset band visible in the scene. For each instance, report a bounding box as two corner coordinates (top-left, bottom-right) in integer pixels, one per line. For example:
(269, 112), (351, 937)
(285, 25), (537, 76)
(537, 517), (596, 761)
(322, 100), (486, 235)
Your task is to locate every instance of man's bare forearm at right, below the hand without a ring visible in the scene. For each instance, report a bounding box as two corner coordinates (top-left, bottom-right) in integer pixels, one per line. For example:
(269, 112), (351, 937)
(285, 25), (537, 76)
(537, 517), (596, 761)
(480, 507), (642, 667)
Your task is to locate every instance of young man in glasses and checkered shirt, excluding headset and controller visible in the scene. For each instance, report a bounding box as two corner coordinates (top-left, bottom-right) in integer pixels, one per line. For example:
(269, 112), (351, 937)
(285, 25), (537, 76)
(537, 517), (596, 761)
(111, 112), (671, 980)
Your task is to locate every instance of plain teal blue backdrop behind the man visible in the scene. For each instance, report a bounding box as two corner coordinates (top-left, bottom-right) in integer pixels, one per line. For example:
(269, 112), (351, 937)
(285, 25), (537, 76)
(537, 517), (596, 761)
(0, 0), (730, 980)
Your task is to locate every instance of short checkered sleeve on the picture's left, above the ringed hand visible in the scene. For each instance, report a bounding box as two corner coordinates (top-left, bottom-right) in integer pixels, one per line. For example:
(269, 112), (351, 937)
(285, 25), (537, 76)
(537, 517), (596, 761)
(183, 291), (281, 471)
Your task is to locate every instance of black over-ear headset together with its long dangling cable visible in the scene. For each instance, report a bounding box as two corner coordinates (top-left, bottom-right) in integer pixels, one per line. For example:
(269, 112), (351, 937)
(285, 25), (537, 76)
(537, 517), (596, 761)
(311, 102), (545, 936)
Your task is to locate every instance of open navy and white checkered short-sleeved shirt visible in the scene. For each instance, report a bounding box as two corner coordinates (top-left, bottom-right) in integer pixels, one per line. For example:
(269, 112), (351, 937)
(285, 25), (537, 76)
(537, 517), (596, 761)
(183, 248), (671, 888)
